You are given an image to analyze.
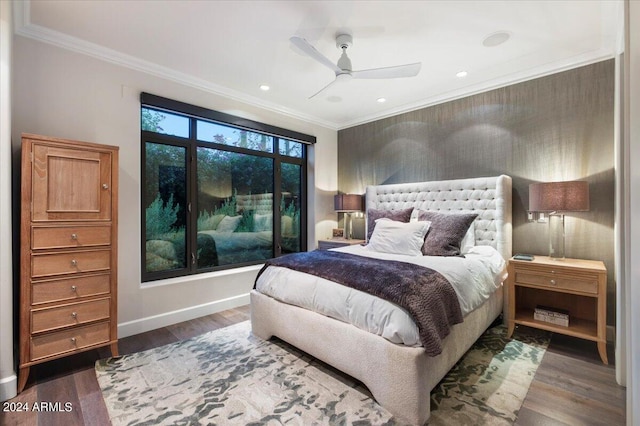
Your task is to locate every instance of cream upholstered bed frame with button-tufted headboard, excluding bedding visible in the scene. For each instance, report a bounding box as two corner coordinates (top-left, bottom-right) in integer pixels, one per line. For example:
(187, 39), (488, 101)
(251, 175), (512, 425)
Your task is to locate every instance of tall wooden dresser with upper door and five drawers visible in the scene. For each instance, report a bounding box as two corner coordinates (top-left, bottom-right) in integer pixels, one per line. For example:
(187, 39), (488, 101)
(18, 134), (118, 392)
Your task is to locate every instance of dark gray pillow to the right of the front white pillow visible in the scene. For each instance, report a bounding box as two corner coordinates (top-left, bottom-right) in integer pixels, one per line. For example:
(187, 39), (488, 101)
(418, 210), (478, 256)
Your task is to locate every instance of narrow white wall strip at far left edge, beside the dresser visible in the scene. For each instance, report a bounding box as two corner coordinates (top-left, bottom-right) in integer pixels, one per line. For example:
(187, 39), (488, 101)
(0, 1), (17, 401)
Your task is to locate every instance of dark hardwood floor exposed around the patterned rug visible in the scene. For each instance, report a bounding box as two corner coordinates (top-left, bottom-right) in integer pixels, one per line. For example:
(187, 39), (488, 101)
(0, 306), (626, 426)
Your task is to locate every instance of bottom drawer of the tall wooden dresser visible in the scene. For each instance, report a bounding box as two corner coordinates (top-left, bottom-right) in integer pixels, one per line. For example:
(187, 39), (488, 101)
(31, 321), (110, 361)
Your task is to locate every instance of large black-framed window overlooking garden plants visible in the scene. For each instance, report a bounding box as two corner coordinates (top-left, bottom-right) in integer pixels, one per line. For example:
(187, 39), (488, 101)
(140, 93), (315, 281)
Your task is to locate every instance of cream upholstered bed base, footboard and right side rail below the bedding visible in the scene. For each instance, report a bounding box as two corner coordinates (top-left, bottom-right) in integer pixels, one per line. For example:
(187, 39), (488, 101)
(251, 290), (503, 425)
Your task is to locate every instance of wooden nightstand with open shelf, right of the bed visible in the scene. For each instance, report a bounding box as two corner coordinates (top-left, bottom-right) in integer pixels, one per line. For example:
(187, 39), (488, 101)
(507, 256), (608, 364)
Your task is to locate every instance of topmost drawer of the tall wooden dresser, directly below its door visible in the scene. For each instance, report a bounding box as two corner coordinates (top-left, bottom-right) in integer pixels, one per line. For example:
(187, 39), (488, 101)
(31, 225), (111, 250)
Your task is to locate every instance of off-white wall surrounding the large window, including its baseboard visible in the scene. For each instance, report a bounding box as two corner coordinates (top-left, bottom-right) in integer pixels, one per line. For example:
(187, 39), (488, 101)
(12, 36), (337, 337)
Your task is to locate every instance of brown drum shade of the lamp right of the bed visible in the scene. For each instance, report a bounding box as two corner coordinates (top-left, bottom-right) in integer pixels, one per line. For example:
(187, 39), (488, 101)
(529, 180), (589, 212)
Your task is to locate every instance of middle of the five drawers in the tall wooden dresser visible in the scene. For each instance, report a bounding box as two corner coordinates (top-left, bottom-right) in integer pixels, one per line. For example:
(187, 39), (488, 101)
(31, 274), (111, 305)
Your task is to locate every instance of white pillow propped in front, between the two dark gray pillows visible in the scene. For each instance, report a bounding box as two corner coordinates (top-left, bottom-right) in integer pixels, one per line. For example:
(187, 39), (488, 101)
(367, 218), (431, 256)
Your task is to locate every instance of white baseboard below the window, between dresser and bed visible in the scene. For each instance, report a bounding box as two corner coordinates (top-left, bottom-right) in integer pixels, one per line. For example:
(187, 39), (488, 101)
(118, 293), (249, 338)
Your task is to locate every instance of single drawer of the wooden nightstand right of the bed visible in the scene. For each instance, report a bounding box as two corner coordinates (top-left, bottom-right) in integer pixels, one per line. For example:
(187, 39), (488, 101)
(515, 268), (598, 295)
